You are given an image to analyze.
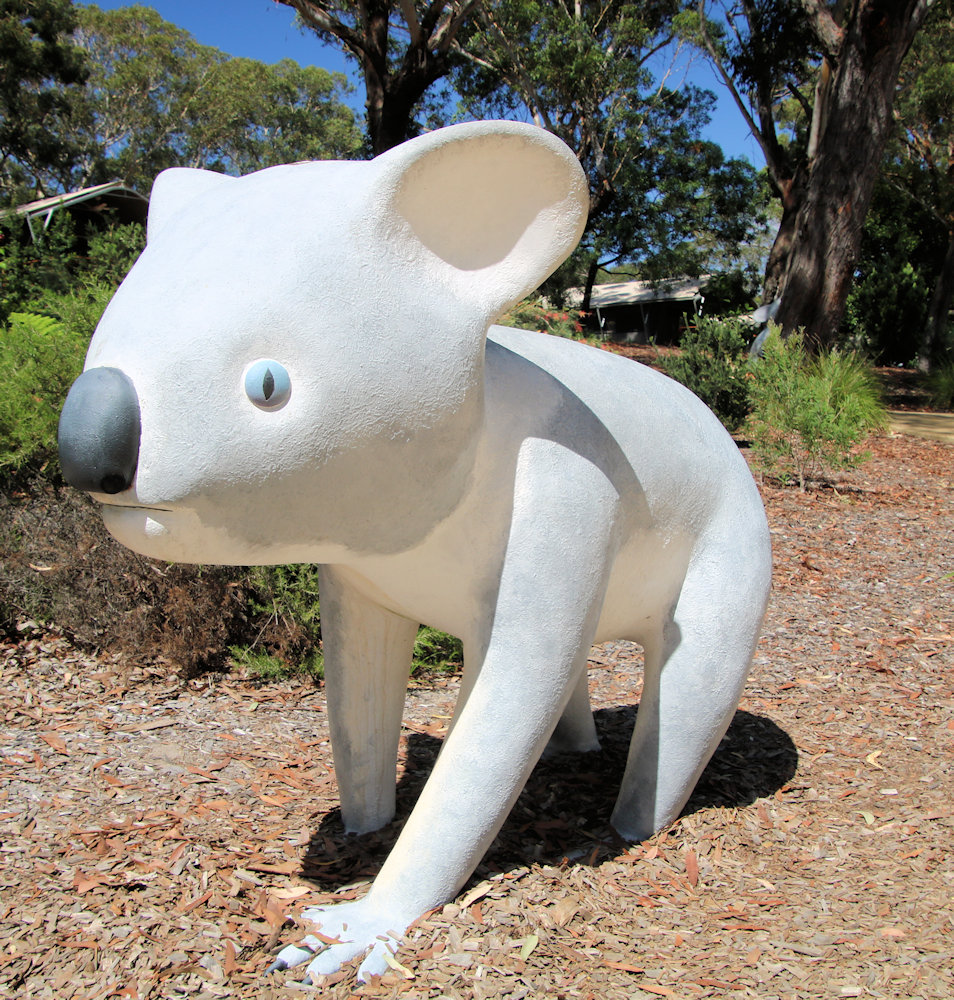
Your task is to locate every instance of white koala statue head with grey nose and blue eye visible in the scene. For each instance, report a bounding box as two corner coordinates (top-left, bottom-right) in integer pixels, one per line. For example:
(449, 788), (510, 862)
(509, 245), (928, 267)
(60, 122), (587, 563)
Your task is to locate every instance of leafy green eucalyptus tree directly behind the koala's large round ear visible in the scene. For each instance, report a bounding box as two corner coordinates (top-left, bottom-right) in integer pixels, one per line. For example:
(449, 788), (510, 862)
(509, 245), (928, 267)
(452, 0), (761, 308)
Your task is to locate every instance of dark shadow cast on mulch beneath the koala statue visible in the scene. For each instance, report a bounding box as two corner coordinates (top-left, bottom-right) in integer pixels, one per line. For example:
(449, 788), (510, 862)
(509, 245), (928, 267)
(302, 706), (798, 890)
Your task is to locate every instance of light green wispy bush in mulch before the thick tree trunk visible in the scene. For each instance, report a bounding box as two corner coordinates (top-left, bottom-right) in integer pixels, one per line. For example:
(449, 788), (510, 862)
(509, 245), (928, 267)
(748, 328), (886, 490)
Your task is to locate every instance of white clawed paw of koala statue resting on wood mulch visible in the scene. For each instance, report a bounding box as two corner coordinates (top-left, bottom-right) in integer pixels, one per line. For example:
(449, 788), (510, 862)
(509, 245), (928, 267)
(268, 899), (407, 982)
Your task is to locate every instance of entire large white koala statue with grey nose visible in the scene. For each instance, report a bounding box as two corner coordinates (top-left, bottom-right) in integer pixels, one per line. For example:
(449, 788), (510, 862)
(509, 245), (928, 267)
(59, 122), (771, 978)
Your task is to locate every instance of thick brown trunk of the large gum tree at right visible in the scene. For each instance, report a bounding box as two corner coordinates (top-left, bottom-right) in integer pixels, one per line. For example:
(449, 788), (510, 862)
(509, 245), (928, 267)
(778, 0), (927, 349)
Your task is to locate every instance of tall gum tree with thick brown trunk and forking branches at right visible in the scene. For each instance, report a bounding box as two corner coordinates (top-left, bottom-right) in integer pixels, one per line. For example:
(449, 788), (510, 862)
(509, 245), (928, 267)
(698, 0), (930, 348)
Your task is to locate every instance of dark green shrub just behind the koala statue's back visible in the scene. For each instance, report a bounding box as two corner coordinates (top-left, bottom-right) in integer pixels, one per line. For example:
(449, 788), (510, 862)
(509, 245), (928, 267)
(662, 316), (751, 431)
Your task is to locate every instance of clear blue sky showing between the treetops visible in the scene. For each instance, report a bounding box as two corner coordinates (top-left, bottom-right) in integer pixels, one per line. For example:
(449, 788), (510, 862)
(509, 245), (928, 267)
(80, 0), (764, 166)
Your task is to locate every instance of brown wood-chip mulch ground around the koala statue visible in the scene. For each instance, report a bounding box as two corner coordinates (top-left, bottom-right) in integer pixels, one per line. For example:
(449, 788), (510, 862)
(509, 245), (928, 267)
(0, 437), (954, 1000)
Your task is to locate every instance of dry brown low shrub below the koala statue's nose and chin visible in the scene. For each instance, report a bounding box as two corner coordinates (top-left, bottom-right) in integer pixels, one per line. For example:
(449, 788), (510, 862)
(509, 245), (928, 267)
(0, 476), (253, 676)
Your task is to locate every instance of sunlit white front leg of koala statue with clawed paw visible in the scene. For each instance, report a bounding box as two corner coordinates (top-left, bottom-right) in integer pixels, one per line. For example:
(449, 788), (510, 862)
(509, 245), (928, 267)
(279, 448), (618, 978)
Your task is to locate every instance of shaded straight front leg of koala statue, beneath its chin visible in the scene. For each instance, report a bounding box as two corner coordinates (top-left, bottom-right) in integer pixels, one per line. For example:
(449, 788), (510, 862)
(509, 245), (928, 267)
(318, 566), (417, 833)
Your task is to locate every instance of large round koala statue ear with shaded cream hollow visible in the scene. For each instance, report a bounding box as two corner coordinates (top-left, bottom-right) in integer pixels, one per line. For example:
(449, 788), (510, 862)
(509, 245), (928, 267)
(374, 122), (589, 316)
